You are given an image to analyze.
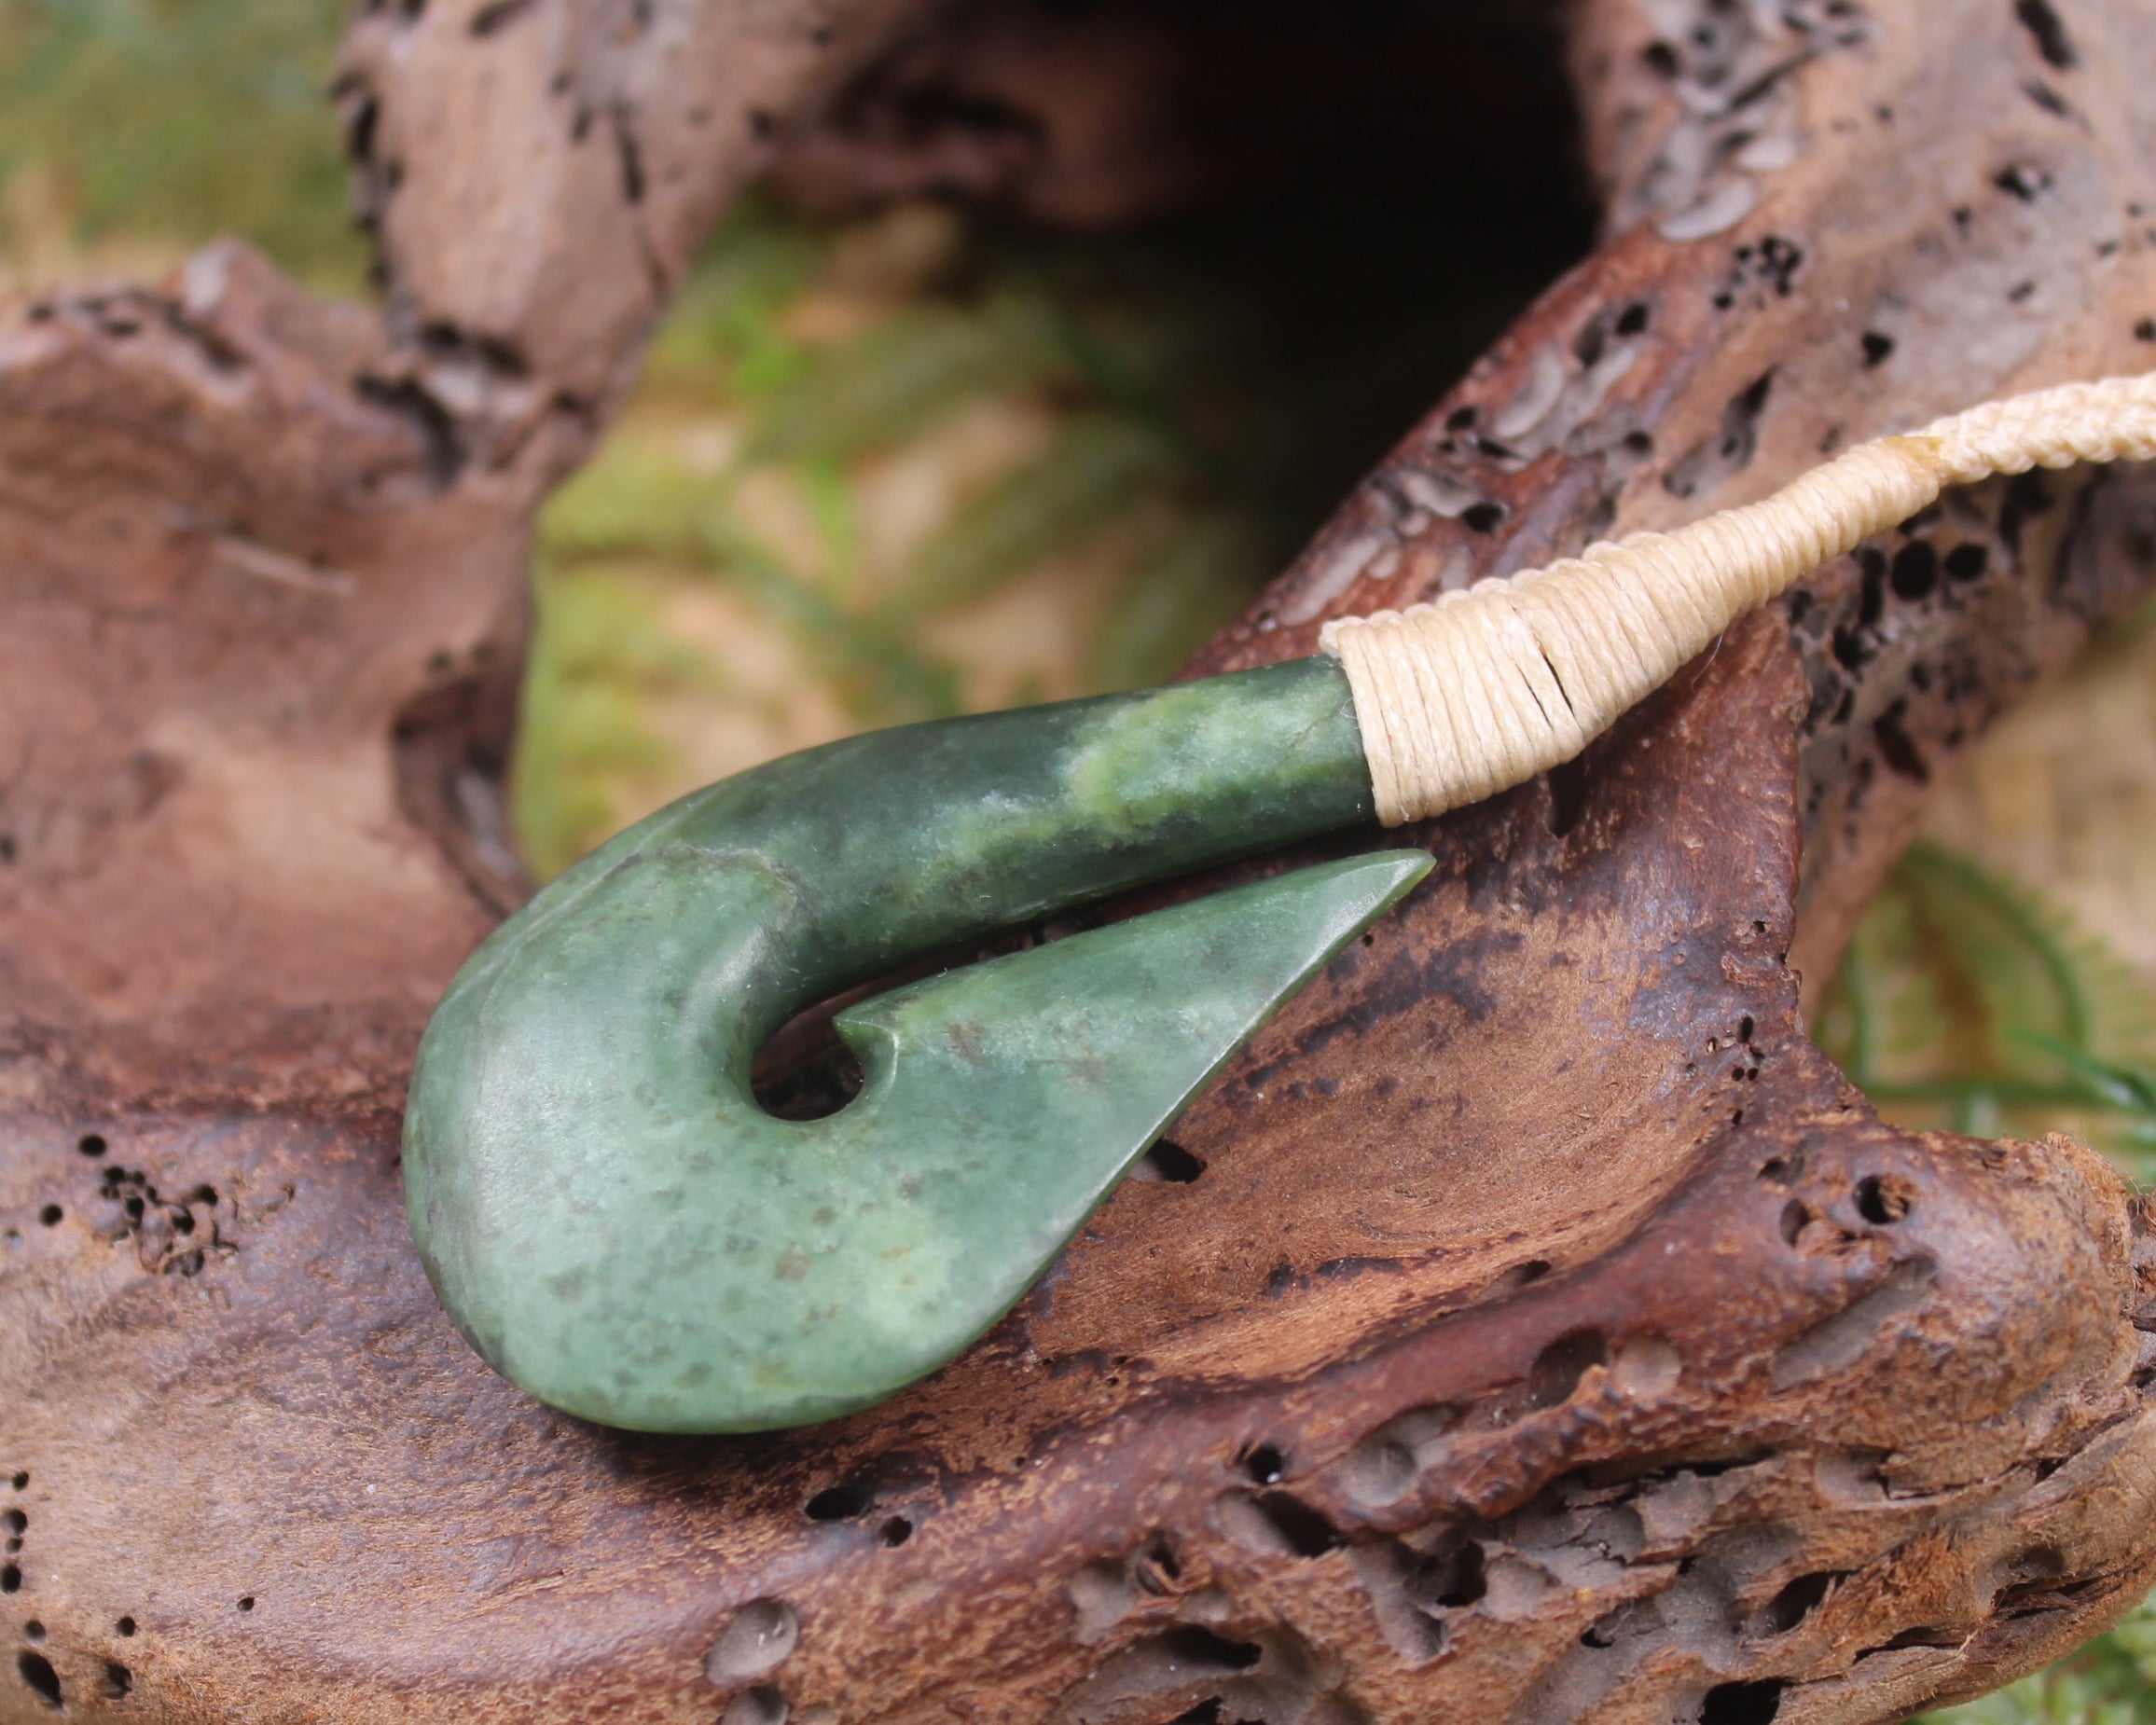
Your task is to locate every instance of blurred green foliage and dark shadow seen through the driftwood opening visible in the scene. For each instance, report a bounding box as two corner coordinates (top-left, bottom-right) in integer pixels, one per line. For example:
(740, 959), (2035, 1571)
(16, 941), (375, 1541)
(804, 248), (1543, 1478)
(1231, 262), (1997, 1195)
(516, 188), (1568, 876)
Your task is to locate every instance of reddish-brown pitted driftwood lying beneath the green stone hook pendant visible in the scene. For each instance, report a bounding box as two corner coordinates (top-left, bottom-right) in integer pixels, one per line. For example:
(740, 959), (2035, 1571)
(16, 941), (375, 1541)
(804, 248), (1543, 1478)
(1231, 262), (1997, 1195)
(0, 0), (2156, 1725)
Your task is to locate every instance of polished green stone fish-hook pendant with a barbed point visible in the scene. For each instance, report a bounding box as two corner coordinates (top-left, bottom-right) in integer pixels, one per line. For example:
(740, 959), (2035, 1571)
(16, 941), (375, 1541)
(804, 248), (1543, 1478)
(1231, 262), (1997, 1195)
(406, 660), (1430, 1432)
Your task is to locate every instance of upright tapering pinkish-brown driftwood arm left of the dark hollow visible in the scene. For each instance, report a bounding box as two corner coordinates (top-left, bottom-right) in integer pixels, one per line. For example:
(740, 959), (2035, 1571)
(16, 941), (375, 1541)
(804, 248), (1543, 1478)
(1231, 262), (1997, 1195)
(334, 0), (952, 485)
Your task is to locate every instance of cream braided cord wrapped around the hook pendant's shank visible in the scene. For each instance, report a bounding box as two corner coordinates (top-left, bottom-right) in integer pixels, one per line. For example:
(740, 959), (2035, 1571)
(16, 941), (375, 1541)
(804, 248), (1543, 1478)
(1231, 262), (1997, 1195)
(1318, 373), (2156, 826)
